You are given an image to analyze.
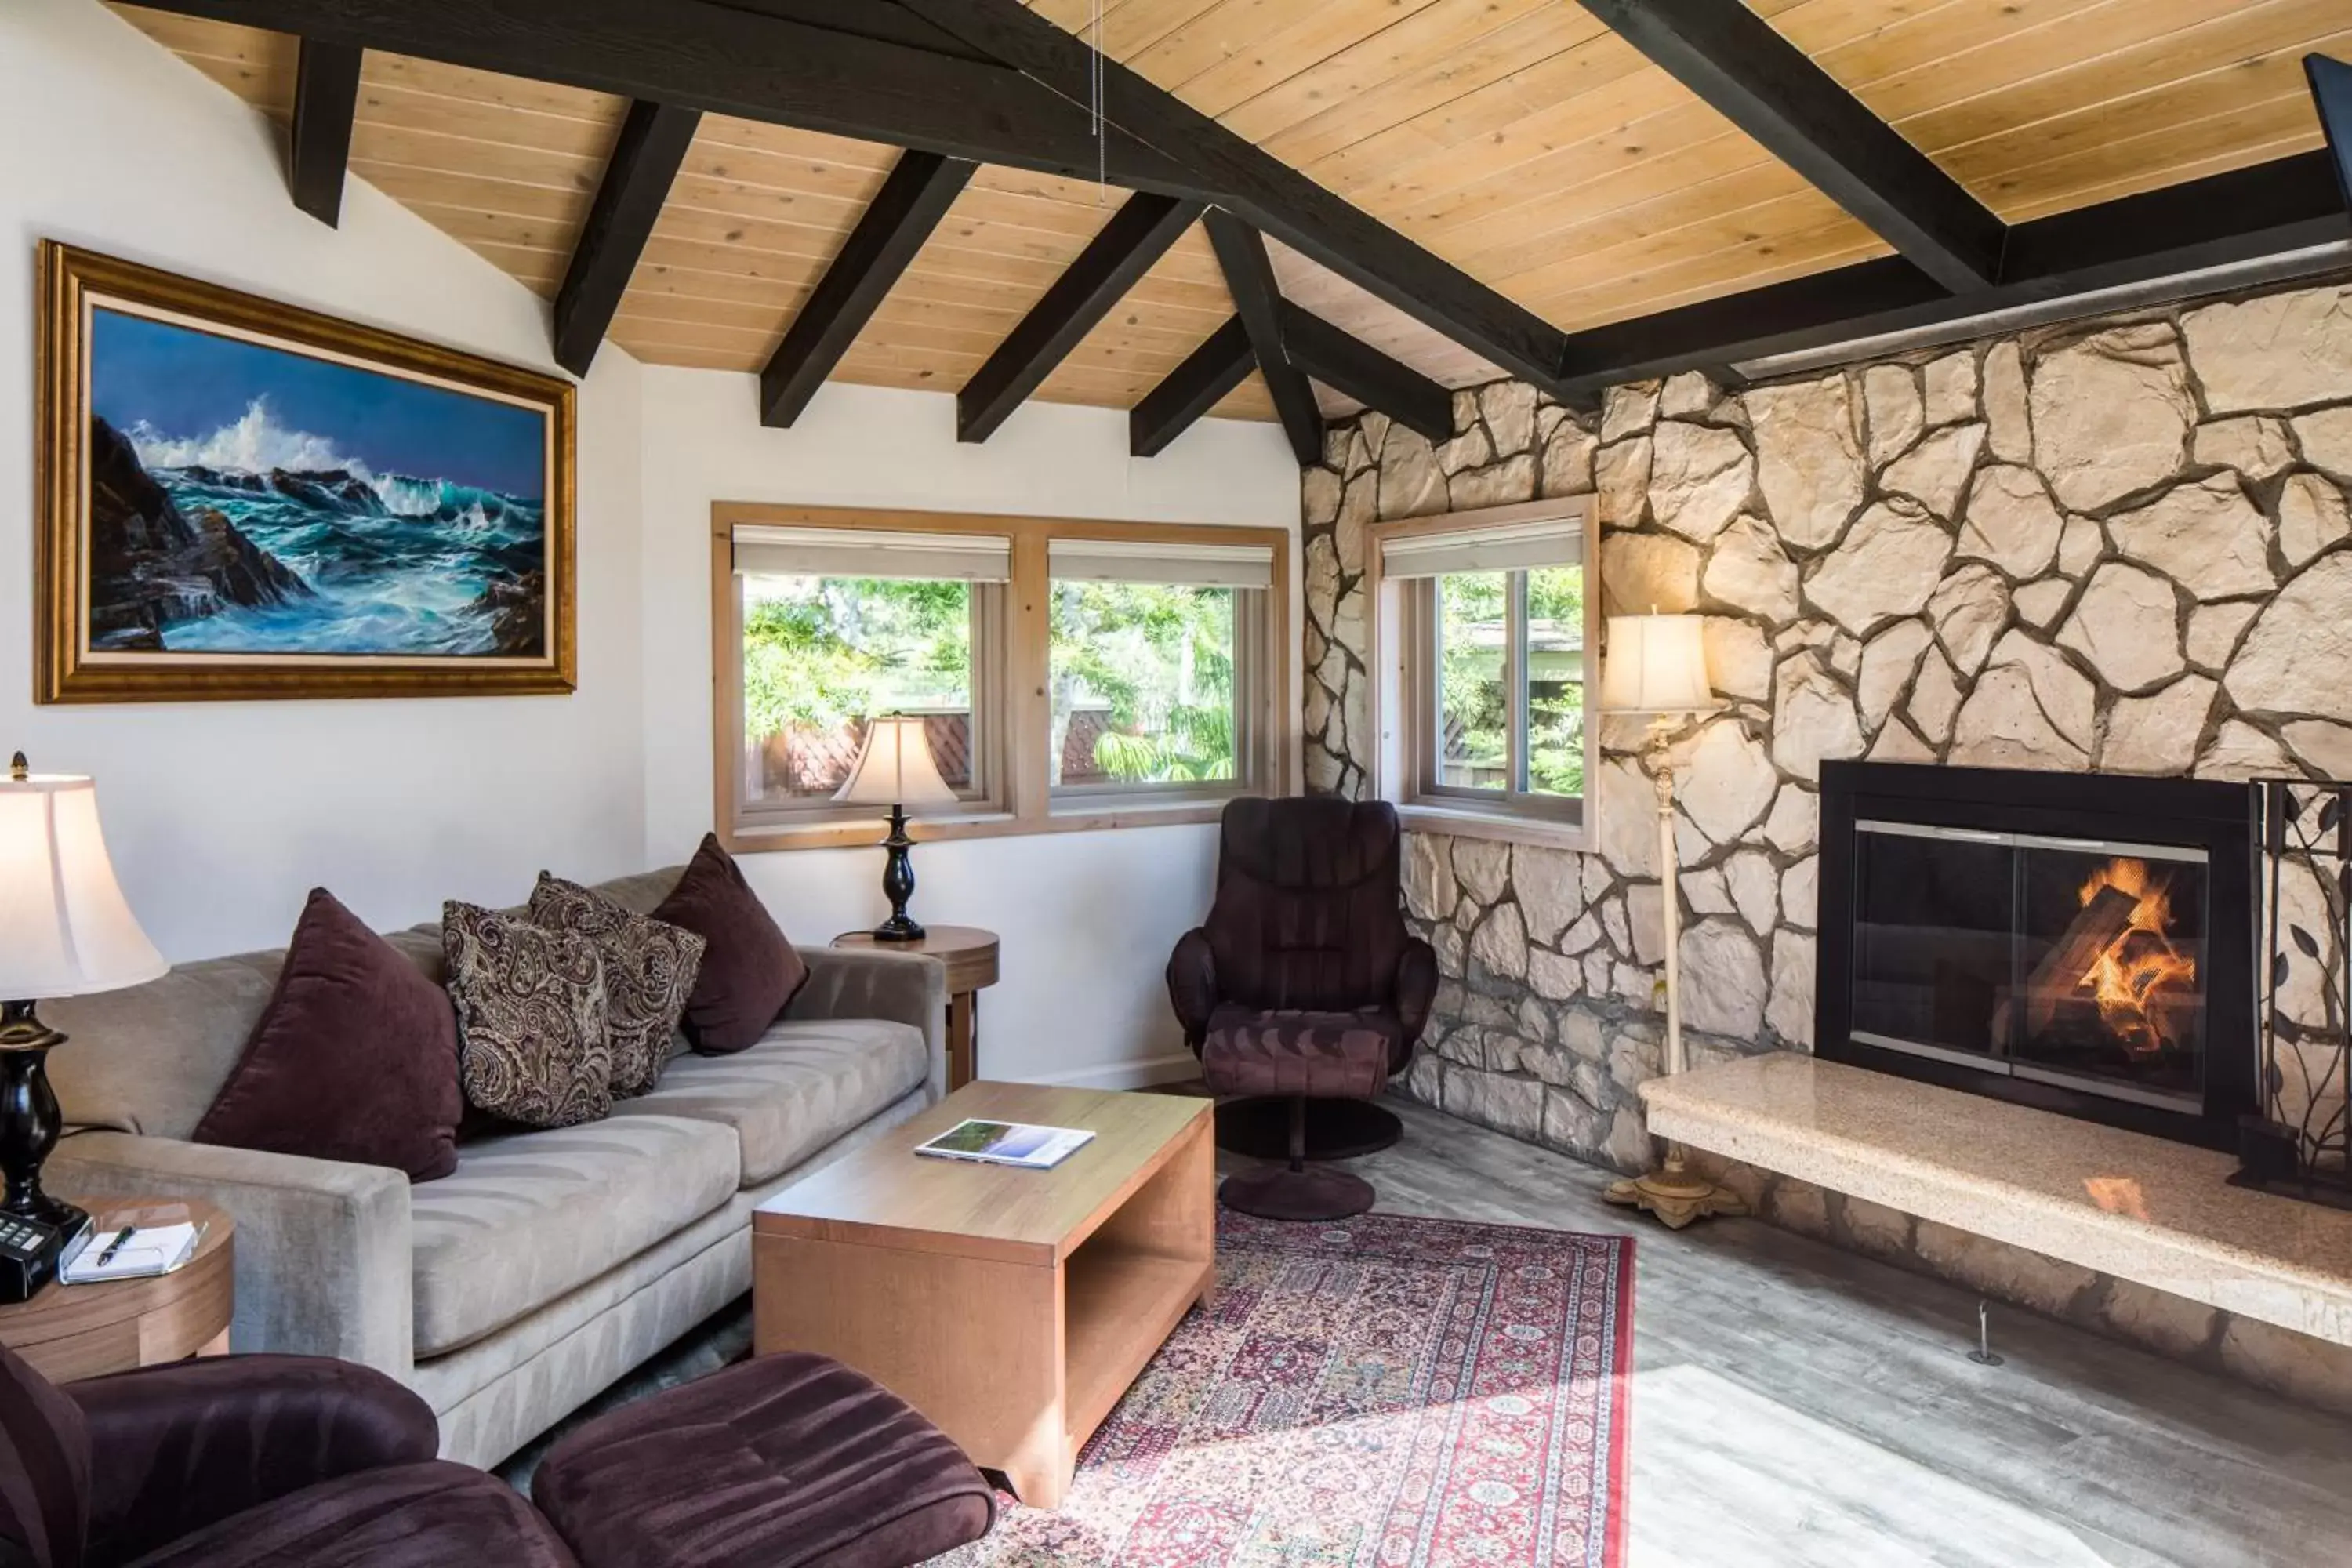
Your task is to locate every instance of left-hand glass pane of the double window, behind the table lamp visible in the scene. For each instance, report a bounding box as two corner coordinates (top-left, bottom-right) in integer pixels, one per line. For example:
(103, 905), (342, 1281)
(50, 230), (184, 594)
(743, 576), (974, 806)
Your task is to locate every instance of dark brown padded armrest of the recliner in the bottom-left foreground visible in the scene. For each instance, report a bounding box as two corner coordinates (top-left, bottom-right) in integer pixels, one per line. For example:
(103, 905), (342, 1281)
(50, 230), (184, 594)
(66, 1356), (440, 1566)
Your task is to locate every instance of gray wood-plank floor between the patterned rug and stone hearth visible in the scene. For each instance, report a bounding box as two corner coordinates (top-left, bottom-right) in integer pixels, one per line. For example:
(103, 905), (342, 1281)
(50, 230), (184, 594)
(1308, 1102), (2352, 1568)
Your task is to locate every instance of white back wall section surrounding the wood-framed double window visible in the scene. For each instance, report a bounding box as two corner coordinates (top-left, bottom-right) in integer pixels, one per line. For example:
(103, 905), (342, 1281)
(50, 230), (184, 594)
(644, 367), (1298, 1086)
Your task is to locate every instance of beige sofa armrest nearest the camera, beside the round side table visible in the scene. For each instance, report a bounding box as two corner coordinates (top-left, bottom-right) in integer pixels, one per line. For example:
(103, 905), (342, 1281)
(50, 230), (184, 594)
(42, 1133), (416, 1382)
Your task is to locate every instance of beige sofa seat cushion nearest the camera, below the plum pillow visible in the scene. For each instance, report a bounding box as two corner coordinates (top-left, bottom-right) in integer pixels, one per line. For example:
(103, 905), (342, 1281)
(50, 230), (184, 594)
(409, 1116), (741, 1359)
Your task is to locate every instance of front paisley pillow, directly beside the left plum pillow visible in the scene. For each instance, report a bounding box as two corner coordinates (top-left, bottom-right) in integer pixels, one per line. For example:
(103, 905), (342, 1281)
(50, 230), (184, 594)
(442, 900), (612, 1126)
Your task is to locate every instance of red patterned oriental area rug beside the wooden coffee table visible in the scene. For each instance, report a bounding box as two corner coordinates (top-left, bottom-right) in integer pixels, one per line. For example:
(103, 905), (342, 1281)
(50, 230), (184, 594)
(938, 1213), (1632, 1568)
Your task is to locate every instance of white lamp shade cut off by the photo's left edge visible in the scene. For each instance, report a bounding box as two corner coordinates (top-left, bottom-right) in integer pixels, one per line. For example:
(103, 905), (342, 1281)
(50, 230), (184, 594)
(0, 774), (169, 1001)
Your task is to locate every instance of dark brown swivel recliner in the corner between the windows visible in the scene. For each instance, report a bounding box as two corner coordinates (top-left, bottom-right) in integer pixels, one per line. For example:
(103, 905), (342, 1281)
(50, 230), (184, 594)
(1169, 797), (1437, 1220)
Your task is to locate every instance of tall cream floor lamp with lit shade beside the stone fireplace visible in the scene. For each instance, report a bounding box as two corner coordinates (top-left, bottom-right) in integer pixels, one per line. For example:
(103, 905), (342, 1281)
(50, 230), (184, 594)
(1602, 614), (1748, 1229)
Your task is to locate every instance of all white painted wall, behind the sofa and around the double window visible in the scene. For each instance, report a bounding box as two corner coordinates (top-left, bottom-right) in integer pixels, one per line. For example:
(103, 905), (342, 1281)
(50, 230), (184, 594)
(0, 0), (1298, 1083)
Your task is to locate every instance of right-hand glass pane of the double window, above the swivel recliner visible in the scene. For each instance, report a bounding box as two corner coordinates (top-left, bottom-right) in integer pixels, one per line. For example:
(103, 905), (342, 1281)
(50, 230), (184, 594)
(1049, 579), (1235, 785)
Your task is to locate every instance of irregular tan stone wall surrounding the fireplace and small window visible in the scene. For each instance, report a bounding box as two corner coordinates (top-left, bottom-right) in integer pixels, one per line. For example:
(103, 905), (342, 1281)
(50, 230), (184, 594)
(1303, 276), (2352, 1408)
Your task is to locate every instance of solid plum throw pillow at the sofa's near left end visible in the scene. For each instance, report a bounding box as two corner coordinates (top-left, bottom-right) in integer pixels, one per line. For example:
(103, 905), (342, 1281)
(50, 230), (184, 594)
(193, 888), (466, 1182)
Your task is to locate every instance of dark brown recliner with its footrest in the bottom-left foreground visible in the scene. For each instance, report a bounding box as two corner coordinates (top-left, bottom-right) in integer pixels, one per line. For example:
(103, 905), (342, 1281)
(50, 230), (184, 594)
(0, 1335), (995, 1568)
